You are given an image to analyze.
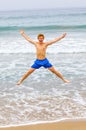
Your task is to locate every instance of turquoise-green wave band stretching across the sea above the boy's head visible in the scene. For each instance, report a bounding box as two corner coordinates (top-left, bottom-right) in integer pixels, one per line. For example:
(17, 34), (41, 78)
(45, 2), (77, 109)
(0, 25), (86, 31)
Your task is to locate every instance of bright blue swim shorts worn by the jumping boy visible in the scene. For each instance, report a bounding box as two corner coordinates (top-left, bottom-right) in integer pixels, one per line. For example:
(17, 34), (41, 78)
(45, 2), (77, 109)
(31, 58), (52, 69)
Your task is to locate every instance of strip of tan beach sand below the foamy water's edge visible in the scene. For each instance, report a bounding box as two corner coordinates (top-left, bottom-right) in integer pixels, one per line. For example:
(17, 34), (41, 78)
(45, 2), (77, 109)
(0, 120), (86, 130)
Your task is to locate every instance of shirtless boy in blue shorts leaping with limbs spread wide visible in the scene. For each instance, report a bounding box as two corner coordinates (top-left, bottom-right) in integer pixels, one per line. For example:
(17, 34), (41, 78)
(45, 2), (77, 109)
(17, 30), (70, 85)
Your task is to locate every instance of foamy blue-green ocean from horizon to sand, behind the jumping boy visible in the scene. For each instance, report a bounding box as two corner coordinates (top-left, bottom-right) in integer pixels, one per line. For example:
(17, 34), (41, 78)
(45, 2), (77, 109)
(0, 8), (86, 127)
